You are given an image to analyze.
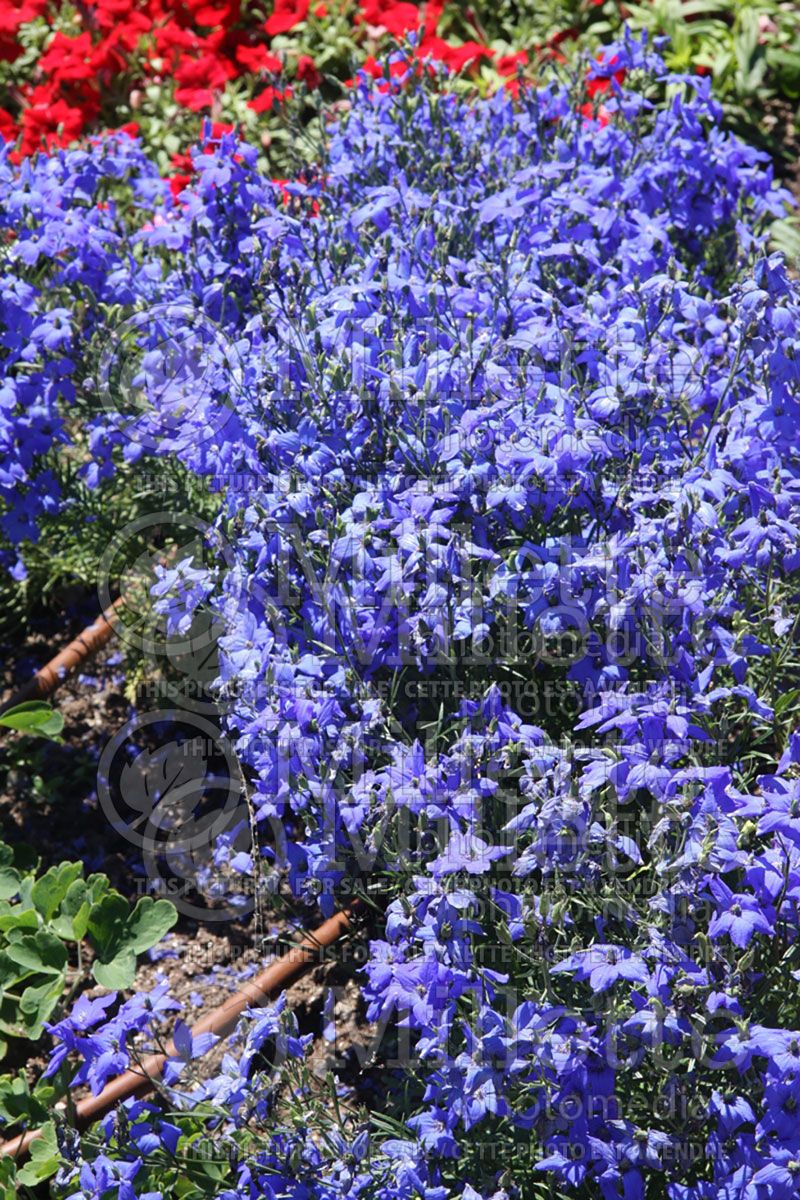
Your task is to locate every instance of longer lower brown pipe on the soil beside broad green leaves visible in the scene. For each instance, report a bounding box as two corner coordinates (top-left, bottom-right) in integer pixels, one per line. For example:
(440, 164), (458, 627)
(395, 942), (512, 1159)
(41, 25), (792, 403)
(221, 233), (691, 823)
(0, 904), (356, 1158)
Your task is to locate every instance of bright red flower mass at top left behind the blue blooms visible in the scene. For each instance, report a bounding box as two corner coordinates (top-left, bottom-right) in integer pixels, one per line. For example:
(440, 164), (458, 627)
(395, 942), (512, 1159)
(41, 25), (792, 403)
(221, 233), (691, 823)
(0, 0), (544, 162)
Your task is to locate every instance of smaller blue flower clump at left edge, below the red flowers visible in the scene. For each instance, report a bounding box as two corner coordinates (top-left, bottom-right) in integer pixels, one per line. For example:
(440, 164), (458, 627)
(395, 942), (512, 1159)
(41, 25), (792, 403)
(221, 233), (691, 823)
(0, 136), (166, 578)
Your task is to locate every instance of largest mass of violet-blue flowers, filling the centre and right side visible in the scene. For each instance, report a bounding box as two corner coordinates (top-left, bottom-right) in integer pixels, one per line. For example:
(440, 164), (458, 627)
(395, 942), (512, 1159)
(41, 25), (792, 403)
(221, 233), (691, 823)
(10, 38), (800, 1200)
